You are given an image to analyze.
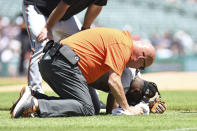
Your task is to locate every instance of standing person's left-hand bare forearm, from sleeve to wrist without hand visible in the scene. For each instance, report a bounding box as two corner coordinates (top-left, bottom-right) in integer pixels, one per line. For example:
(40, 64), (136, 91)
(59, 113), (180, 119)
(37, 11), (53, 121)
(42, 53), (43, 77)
(46, 1), (70, 29)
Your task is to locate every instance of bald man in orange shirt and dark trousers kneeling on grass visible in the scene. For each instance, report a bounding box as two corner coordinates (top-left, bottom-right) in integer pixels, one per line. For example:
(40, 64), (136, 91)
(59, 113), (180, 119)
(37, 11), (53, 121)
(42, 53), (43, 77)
(12, 28), (155, 118)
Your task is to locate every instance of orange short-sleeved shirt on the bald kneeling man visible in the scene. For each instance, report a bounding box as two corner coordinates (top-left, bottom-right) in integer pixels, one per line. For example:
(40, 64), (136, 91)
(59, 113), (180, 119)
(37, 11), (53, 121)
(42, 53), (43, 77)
(60, 28), (133, 84)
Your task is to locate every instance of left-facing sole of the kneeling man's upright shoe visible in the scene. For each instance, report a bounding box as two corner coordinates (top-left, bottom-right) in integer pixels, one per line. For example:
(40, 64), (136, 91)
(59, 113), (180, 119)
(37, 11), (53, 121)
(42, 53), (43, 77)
(11, 87), (29, 118)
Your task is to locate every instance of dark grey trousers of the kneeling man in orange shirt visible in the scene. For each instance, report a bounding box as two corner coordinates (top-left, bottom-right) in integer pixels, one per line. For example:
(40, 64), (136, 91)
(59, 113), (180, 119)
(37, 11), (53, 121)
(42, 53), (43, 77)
(38, 55), (95, 117)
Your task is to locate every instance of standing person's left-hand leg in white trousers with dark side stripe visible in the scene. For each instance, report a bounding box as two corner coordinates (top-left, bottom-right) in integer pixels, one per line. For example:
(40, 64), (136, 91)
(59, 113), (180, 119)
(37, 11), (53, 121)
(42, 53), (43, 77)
(23, 5), (46, 93)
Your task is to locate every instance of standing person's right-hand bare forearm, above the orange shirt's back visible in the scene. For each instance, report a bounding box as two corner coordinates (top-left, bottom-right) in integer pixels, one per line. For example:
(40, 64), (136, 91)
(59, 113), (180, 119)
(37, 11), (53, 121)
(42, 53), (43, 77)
(82, 4), (102, 30)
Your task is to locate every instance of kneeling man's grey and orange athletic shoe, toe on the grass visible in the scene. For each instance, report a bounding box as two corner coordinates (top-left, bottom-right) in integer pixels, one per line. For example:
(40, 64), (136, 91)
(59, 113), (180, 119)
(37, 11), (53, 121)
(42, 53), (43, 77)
(11, 86), (36, 118)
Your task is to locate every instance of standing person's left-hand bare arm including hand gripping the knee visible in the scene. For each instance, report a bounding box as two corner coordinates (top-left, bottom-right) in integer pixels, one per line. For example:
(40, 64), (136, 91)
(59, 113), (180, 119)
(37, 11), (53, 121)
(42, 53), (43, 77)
(37, 0), (70, 42)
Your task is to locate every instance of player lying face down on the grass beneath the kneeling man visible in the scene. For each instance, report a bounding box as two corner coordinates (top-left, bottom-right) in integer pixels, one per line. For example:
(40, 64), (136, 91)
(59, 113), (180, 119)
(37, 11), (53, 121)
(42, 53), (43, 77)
(89, 68), (166, 113)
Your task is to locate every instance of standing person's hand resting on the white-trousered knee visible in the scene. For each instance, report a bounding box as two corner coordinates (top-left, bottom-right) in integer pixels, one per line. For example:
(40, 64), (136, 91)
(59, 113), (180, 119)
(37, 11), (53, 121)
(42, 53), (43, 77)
(37, 27), (53, 42)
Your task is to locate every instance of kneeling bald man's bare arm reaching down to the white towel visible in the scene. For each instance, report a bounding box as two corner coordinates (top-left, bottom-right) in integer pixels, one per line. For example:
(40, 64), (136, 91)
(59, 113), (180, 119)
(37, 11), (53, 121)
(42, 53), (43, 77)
(108, 70), (143, 115)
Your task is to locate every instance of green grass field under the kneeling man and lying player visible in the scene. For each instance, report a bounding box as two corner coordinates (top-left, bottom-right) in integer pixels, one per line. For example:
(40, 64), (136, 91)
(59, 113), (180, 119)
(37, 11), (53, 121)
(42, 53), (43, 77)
(0, 91), (197, 131)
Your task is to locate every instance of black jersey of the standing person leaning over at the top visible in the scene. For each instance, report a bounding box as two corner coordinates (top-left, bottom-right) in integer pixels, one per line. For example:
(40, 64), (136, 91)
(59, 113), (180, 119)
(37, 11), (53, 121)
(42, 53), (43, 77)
(24, 0), (107, 20)
